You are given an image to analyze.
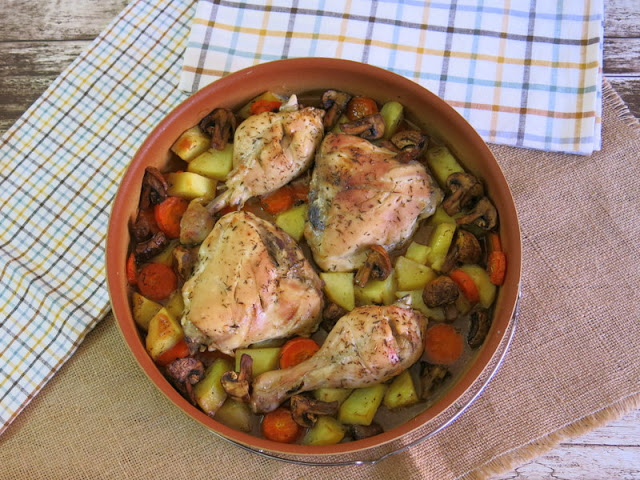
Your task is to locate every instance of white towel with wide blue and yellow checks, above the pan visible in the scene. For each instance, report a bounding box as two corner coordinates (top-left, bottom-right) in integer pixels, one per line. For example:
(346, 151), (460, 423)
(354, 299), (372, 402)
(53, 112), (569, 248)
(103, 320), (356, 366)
(180, 0), (604, 154)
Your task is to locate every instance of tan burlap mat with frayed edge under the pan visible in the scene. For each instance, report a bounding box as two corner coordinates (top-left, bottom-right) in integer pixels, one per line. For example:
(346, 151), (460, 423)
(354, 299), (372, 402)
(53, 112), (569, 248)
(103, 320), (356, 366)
(0, 80), (640, 480)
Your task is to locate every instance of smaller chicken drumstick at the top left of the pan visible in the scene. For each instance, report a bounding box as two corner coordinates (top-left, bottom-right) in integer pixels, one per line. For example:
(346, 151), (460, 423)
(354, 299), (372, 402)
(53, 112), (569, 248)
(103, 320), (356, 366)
(207, 107), (324, 214)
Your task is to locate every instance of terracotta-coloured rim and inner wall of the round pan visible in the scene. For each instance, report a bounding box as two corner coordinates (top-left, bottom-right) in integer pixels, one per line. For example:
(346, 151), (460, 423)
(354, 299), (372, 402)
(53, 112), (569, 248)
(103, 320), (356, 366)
(106, 58), (521, 459)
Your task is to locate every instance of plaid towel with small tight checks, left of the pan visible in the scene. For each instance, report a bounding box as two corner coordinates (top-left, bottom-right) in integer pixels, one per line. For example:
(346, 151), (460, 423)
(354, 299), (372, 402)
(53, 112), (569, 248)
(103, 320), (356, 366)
(0, 0), (195, 432)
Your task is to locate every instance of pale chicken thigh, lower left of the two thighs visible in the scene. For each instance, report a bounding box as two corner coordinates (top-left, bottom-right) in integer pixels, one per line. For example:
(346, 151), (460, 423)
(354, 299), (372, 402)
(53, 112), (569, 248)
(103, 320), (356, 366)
(182, 212), (323, 354)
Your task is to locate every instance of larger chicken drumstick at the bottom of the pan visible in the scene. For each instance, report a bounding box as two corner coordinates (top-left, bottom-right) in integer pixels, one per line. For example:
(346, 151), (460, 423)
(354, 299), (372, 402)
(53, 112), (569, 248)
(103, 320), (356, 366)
(251, 305), (427, 413)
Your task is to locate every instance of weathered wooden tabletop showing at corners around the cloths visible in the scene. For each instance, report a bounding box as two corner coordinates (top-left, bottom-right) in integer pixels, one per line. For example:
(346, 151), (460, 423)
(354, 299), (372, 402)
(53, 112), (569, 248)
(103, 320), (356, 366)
(0, 0), (640, 480)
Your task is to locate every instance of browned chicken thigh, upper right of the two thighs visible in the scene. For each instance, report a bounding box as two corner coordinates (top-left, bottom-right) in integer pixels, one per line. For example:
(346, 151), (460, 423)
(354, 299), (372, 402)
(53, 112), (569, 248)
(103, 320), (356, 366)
(304, 133), (443, 272)
